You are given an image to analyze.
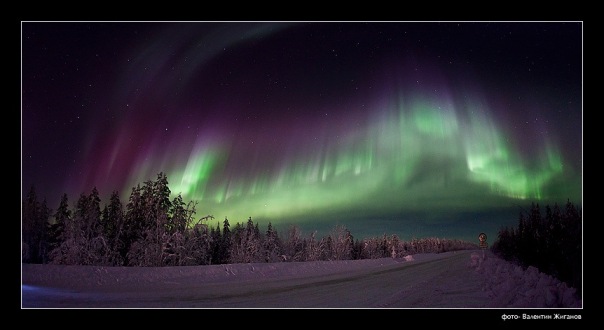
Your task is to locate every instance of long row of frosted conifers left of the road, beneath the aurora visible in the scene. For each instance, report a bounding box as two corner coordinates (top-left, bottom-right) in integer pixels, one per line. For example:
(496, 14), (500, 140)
(22, 173), (477, 266)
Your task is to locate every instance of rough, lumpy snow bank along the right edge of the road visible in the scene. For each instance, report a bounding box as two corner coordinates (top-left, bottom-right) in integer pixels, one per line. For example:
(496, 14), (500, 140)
(468, 253), (582, 308)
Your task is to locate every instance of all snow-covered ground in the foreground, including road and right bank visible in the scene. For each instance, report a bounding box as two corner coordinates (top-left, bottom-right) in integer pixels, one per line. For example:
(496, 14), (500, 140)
(21, 250), (582, 309)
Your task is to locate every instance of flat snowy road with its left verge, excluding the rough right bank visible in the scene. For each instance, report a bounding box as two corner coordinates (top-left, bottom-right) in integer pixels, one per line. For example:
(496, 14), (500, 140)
(22, 251), (490, 308)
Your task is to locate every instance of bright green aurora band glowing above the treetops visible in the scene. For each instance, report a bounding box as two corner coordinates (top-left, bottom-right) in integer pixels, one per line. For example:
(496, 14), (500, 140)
(120, 93), (580, 228)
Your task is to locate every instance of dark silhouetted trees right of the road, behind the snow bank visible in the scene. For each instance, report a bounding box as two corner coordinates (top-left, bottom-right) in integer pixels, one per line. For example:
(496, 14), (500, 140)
(491, 201), (583, 294)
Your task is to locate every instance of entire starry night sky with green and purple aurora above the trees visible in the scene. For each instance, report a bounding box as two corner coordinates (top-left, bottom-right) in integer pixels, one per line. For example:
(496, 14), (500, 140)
(21, 22), (583, 243)
